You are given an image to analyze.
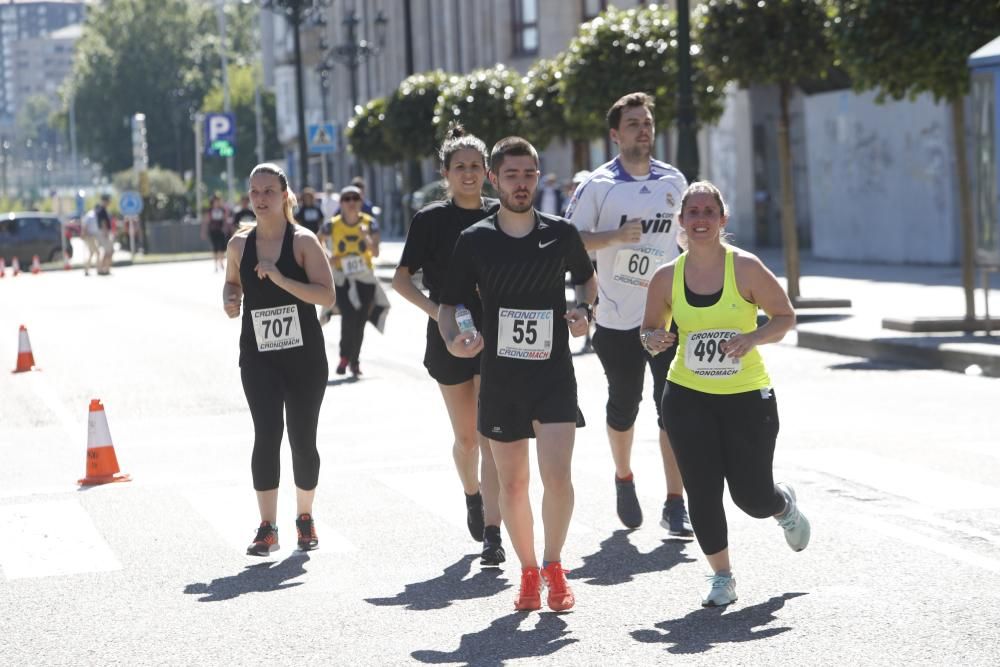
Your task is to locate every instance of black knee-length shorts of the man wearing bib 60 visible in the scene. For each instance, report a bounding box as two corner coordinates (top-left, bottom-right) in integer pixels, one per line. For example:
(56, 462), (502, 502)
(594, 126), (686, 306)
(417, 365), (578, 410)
(593, 325), (677, 431)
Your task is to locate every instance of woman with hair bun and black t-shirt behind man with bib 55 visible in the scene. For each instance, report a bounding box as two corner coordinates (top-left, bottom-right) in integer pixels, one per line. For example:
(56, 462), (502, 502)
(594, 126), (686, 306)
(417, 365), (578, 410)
(392, 125), (506, 565)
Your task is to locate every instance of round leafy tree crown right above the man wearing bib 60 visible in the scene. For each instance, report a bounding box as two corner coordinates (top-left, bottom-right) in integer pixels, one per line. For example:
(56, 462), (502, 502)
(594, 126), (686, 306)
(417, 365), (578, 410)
(561, 5), (723, 138)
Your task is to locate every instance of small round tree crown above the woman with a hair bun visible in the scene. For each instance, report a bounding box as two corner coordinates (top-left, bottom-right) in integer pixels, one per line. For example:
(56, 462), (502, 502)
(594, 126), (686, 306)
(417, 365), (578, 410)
(433, 65), (523, 147)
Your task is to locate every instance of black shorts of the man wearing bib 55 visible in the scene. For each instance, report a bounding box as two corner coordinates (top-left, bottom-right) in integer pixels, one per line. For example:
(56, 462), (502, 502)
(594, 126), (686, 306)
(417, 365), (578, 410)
(477, 376), (586, 442)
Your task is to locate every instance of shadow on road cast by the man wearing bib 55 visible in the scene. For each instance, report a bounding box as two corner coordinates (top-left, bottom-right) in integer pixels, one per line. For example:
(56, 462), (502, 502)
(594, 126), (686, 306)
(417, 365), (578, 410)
(410, 612), (580, 667)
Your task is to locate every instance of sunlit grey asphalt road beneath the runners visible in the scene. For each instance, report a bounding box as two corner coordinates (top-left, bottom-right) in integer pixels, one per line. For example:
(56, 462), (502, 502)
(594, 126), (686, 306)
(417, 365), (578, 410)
(0, 262), (1000, 665)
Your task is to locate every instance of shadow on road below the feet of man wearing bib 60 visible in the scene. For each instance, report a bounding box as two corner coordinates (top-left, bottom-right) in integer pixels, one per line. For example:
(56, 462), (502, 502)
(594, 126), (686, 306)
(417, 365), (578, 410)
(569, 529), (696, 586)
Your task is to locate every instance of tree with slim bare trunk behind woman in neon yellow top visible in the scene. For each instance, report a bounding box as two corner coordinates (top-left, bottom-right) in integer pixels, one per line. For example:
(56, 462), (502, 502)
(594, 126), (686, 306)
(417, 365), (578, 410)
(696, 0), (834, 302)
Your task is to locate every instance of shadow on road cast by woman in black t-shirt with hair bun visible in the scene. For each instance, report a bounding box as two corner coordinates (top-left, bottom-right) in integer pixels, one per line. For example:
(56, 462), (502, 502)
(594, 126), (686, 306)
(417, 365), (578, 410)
(365, 555), (510, 611)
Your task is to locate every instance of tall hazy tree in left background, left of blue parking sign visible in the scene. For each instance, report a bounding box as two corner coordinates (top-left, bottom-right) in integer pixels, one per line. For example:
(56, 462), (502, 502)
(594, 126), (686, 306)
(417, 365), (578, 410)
(65, 0), (257, 172)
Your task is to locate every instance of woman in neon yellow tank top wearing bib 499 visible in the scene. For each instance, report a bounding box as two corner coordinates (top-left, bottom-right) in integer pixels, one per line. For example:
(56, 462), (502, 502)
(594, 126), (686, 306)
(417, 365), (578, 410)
(640, 181), (810, 607)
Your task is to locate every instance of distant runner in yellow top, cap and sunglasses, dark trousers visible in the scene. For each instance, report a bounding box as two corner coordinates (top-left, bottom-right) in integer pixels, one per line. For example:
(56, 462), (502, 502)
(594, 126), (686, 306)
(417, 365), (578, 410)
(320, 185), (380, 377)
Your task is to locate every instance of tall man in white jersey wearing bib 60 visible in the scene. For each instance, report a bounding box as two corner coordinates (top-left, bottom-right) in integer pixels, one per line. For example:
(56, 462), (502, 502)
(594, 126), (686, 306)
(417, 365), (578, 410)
(568, 93), (692, 537)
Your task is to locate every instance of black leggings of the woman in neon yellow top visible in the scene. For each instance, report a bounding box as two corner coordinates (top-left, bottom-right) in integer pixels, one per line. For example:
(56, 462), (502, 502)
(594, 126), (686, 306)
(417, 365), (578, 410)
(663, 382), (785, 555)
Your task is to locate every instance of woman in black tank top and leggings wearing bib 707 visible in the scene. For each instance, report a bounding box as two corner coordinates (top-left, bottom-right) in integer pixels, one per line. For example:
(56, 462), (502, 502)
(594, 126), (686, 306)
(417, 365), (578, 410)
(222, 164), (336, 556)
